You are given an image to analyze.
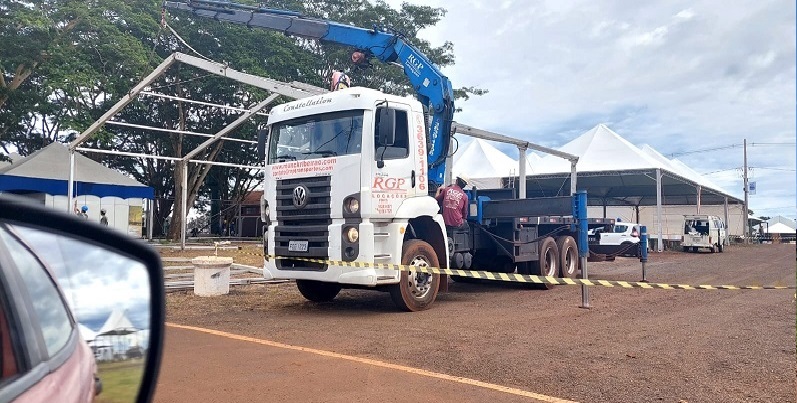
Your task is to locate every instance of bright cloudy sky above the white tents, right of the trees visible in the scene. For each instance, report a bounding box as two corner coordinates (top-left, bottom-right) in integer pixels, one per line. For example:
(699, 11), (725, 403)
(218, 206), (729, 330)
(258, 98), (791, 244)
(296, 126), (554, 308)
(389, 0), (797, 218)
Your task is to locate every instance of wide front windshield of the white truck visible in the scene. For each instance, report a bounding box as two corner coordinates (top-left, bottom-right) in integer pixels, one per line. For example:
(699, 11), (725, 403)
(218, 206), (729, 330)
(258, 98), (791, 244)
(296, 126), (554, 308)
(268, 110), (364, 164)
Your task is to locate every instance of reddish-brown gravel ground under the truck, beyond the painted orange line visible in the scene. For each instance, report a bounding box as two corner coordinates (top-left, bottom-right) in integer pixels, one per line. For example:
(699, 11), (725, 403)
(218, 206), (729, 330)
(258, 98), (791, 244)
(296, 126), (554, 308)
(158, 245), (797, 403)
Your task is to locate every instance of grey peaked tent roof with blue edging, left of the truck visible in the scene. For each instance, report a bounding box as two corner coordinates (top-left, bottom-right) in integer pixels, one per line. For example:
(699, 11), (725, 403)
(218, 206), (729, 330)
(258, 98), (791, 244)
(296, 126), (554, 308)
(0, 143), (155, 199)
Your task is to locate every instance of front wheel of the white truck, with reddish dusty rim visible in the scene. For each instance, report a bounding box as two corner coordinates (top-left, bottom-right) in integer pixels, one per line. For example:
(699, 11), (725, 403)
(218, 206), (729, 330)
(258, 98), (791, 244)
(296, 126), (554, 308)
(390, 239), (440, 312)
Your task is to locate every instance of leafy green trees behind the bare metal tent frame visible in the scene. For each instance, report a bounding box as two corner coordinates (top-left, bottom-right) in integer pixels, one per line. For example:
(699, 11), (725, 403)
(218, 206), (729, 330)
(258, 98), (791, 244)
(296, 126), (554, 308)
(0, 0), (484, 238)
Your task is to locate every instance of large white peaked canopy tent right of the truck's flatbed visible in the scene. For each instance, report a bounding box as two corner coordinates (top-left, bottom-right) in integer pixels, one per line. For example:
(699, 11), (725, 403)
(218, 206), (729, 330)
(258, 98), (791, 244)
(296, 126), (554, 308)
(470, 124), (744, 251)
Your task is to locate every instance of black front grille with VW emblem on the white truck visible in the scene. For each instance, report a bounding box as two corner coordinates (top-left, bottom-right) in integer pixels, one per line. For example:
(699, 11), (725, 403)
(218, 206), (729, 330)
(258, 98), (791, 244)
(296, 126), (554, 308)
(274, 176), (332, 270)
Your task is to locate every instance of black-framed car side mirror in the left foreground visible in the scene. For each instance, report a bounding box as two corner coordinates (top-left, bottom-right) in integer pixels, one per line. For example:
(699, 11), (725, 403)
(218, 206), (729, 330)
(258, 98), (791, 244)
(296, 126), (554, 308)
(0, 195), (165, 402)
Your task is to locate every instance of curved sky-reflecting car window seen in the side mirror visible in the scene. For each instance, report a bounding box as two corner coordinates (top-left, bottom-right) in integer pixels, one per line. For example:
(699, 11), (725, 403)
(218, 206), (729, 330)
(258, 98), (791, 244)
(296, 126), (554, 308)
(0, 229), (72, 357)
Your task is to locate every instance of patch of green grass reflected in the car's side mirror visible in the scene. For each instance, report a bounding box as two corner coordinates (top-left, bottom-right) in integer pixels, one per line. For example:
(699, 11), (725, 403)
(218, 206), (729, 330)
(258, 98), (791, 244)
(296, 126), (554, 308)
(96, 359), (144, 403)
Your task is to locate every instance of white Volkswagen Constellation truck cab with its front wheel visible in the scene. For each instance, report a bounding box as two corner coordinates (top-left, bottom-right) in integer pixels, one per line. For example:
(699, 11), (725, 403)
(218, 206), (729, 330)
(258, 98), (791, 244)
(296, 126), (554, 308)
(261, 87), (447, 310)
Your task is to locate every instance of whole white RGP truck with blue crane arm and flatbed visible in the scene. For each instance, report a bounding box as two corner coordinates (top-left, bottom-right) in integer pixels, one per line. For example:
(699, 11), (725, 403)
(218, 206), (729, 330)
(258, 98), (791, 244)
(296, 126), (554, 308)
(164, 0), (604, 311)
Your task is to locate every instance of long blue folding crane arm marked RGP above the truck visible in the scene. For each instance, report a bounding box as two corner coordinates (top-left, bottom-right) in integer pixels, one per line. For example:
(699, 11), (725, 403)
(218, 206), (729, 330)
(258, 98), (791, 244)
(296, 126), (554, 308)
(163, 0), (454, 189)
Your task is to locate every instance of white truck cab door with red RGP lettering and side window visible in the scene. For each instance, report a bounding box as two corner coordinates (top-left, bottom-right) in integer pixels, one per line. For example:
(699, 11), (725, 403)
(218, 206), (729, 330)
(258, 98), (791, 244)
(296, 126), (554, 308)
(371, 102), (418, 218)
